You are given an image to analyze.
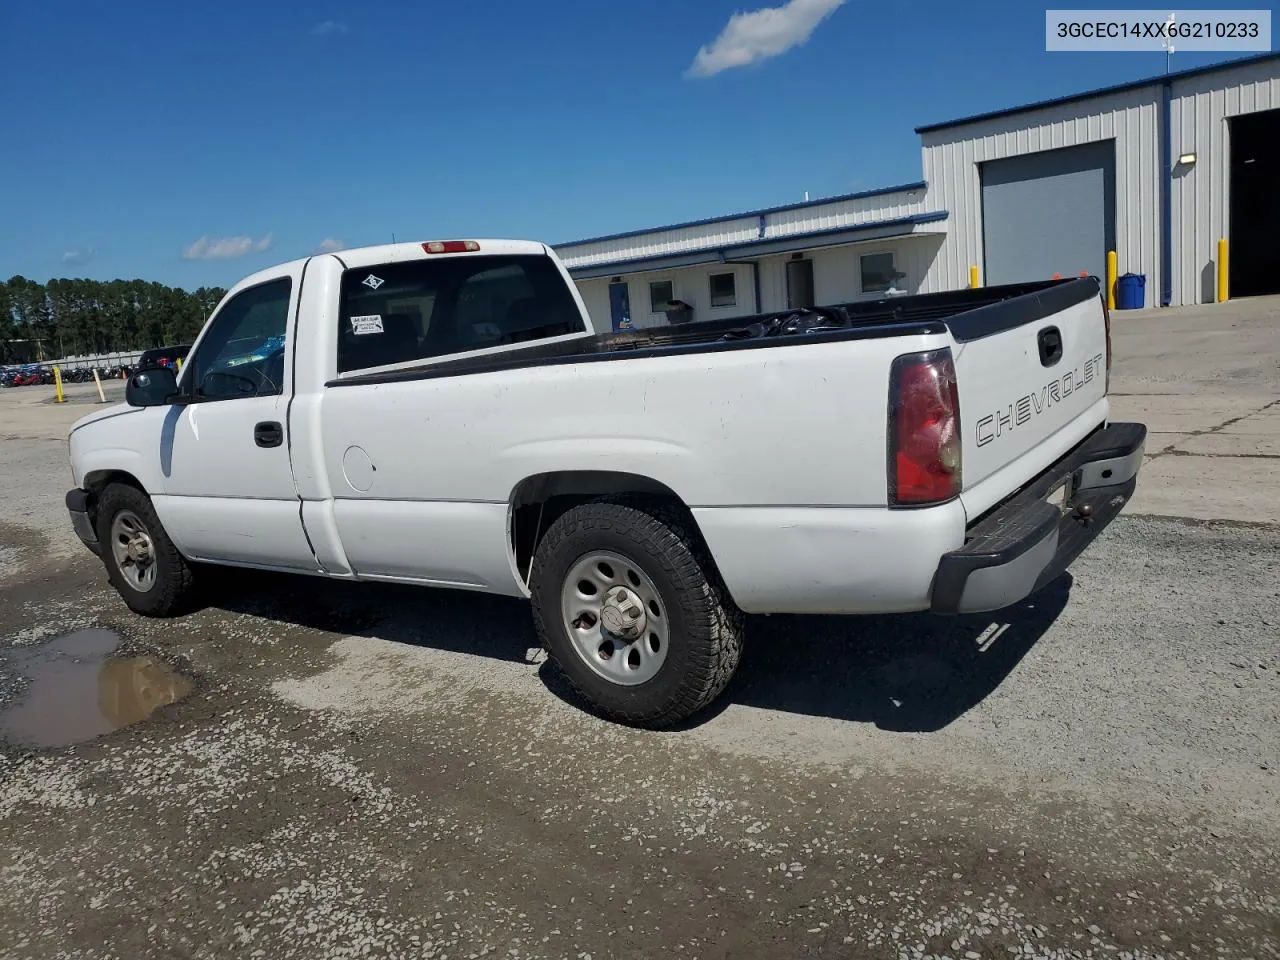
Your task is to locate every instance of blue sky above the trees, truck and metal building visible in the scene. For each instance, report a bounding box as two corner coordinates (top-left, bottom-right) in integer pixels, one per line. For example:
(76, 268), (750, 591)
(0, 0), (1259, 288)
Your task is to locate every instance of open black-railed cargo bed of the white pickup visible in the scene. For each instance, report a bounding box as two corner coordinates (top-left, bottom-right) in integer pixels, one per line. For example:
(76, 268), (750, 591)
(328, 278), (1100, 387)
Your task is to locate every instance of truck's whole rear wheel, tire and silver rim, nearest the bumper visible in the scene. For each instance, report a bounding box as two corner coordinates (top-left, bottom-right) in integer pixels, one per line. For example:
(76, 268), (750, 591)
(530, 502), (742, 728)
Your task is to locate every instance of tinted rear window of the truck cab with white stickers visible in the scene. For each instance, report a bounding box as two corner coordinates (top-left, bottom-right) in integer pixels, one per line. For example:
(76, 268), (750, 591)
(338, 256), (586, 374)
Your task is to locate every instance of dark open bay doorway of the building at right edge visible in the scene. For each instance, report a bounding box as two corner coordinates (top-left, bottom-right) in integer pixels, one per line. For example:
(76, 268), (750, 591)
(1228, 110), (1280, 297)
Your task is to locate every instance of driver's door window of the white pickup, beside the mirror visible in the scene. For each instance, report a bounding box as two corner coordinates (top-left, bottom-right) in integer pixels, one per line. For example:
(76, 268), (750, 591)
(184, 276), (293, 401)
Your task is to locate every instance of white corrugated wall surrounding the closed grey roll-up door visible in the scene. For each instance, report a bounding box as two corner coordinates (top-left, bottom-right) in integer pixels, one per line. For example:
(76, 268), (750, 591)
(922, 83), (1161, 302)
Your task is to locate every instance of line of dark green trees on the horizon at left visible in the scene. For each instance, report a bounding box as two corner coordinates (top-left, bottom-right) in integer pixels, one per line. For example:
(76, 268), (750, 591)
(0, 276), (227, 364)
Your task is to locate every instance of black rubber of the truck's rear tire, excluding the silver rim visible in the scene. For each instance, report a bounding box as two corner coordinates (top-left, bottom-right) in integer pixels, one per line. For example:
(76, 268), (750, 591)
(530, 499), (744, 730)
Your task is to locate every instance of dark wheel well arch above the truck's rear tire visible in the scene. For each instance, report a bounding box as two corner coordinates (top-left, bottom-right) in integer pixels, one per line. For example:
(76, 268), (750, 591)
(509, 470), (687, 582)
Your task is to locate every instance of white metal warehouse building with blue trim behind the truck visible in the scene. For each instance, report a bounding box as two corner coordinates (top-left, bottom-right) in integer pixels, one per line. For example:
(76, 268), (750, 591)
(557, 54), (1280, 329)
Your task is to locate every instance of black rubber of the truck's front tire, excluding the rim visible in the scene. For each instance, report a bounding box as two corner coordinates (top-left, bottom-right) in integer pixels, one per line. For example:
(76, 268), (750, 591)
(97, 484), (196, 617)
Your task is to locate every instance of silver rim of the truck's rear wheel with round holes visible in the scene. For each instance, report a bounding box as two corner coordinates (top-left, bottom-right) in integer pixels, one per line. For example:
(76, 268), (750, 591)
(561, 550), (669, 686)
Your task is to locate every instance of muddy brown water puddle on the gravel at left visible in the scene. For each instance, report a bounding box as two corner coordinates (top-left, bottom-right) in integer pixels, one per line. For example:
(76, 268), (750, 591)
(0, 630), (191, 748)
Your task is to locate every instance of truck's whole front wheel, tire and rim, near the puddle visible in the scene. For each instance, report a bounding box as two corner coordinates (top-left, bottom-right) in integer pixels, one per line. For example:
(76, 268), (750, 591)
(97, 484), (195, 617)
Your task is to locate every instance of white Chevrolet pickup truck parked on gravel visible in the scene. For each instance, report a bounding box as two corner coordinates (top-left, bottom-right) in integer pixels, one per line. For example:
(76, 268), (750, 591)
(67, 241), (1146, 727)
